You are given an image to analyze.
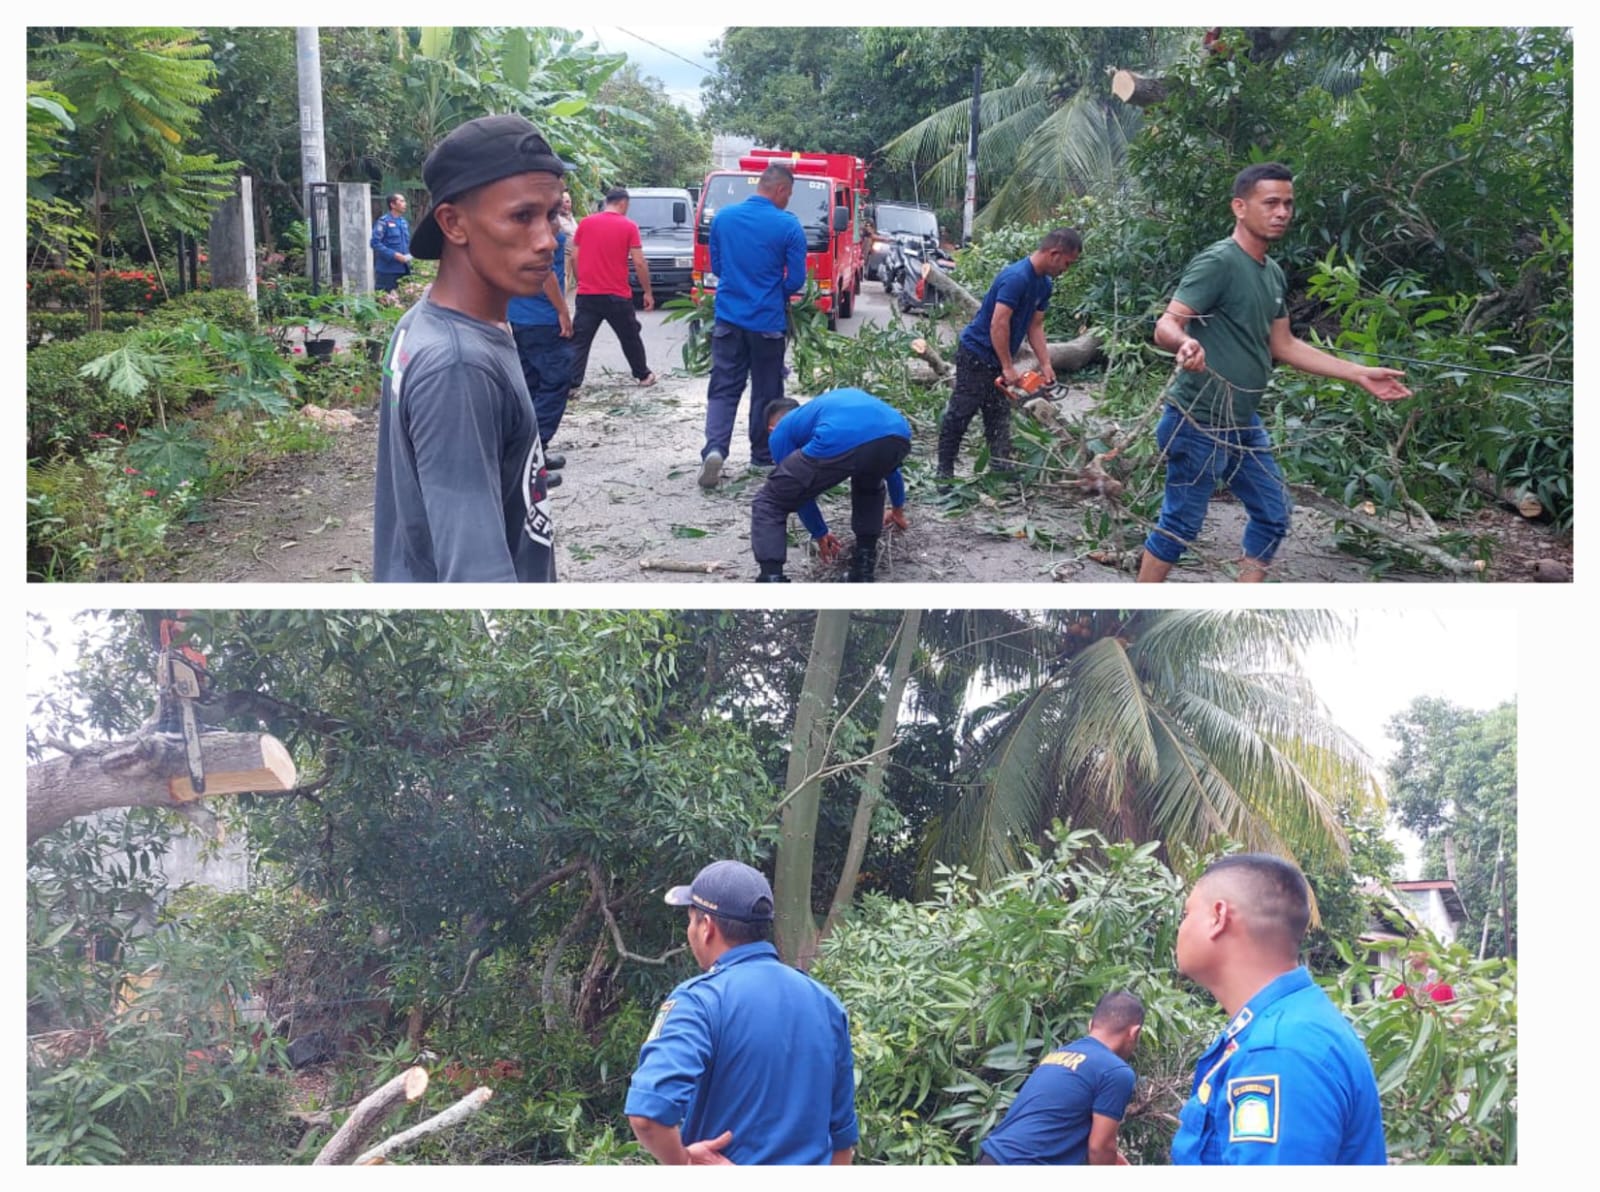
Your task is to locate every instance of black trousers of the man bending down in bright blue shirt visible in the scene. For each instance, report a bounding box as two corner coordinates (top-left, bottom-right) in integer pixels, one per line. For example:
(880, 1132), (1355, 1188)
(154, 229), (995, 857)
(750, 435), (910, 563)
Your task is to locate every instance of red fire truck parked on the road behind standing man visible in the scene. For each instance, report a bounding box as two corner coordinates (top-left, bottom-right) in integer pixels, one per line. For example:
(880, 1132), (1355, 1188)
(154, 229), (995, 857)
(694, 149), (867, 330)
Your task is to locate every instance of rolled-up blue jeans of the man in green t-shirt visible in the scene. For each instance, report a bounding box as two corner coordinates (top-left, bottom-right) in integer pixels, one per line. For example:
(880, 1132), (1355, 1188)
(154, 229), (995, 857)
(1144, 406), (1291, 563)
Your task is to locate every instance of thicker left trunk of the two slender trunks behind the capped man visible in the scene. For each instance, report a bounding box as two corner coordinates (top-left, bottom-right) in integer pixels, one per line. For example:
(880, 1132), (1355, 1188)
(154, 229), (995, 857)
(773, 608), (850, 968)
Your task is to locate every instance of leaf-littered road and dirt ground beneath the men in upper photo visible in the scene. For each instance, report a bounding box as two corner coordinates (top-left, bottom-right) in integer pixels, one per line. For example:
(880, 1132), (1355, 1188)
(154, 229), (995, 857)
(152, 374), (1573, 584)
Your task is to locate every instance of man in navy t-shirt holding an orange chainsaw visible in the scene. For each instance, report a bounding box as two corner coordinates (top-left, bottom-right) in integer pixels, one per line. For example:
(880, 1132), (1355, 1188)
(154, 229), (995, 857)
(938, 227), (1083, 480)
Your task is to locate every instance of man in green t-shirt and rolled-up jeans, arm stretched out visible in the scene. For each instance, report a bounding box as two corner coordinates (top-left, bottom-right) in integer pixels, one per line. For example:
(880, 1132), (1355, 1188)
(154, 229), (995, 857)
(1139, 162), (1411, 584)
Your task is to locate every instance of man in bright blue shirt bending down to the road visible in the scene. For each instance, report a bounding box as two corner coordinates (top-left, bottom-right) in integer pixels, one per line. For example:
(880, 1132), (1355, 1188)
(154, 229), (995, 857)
(750, 389), (910, 584)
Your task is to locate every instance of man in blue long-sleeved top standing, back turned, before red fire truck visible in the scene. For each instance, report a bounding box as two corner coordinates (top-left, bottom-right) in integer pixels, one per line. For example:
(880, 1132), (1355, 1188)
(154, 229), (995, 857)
(699, 165), (805, 488)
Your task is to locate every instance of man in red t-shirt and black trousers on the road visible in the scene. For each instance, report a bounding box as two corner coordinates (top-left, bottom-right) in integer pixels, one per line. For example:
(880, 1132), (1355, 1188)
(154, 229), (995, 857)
(573, 187), (656, 389)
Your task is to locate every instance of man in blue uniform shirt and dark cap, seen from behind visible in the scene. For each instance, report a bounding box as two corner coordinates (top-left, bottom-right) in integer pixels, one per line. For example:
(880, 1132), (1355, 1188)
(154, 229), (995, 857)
(624, 861), (858, 1165)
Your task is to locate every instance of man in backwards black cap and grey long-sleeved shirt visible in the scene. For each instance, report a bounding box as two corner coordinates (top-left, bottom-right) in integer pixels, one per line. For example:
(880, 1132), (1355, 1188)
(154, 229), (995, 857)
(373, 115), (565, 582)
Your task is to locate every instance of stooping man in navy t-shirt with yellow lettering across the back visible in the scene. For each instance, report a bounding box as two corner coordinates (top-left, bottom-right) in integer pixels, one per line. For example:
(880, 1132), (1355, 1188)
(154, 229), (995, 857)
(978, 990), (1144, 1166)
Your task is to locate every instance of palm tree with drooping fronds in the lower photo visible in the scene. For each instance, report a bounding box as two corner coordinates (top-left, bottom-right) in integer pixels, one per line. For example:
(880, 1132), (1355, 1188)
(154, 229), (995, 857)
(925, 610), (1378, 880)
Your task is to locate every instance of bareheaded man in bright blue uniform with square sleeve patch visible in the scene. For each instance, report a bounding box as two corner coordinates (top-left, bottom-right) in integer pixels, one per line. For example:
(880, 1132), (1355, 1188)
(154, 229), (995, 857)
(1173, 853), (1387, 1165)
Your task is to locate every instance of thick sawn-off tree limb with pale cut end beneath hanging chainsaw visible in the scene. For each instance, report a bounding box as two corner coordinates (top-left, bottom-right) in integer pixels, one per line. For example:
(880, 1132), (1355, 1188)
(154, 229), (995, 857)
(27, 733), (294, 843)
